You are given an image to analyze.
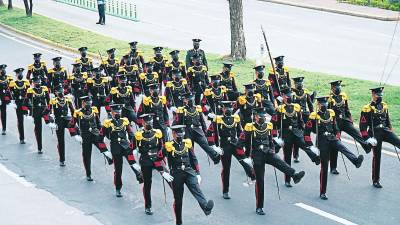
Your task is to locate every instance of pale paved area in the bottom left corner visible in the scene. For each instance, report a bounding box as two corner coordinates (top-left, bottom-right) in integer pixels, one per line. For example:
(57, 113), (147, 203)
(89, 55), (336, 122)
(0, 163), (101, 225)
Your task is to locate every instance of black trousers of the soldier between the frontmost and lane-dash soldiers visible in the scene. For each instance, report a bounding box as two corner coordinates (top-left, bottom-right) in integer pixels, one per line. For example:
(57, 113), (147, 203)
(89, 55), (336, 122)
(221, 144), (255, 193)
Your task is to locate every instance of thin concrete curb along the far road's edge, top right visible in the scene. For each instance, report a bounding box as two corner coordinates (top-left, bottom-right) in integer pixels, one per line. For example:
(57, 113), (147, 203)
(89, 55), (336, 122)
(259, 0), (400, 21)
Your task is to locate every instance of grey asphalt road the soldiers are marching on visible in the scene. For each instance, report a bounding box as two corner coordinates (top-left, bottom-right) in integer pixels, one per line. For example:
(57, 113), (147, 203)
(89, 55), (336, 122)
(0, 28), (400, 225)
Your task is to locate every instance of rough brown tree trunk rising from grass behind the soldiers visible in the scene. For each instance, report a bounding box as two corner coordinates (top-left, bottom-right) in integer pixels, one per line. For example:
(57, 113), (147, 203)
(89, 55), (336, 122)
(228, 0), (246, 60)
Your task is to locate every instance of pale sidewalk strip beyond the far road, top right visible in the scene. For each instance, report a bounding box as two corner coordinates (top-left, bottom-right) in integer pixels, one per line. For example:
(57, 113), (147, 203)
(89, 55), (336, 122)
(259, 0), (399, 21)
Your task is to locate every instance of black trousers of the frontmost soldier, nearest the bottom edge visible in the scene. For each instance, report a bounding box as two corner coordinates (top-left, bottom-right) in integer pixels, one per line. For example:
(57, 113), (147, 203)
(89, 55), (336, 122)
(171, 170), (207, 224)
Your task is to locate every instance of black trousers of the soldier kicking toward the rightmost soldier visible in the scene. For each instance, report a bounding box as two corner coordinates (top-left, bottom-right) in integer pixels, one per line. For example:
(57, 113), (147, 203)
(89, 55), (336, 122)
(331, 119), (371, 169)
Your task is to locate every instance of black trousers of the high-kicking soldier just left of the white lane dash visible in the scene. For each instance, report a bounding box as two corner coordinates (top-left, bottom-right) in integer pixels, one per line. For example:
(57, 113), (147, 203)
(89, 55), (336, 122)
(253, 152), (296, 208)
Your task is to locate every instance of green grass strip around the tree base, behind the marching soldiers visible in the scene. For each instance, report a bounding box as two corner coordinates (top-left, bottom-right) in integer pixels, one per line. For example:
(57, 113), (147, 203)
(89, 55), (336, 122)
(0, 7), (400, 130)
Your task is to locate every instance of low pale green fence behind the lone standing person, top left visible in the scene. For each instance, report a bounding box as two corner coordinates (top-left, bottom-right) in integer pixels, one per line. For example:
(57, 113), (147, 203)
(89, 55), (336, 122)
(54, 0), (139, 21)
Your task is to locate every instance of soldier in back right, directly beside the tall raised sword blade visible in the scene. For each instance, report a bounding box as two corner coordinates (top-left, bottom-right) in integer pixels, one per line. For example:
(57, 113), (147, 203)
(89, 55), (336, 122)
(268, 55), (292, 98)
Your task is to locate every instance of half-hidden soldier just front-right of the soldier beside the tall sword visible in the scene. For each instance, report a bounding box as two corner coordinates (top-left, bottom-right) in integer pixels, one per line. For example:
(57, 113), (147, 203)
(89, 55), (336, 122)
(292, 77), (316, 163)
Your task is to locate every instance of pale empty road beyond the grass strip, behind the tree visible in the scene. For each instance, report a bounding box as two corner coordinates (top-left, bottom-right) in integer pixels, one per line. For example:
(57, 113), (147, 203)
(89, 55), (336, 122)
(11, 0), (400, 85)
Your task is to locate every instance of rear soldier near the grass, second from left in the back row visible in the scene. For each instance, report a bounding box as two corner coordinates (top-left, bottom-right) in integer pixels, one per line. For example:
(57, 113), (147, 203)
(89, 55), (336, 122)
(48, 57), (68, 93)
